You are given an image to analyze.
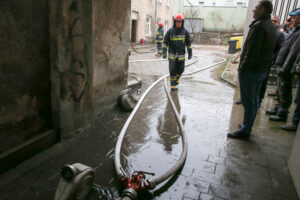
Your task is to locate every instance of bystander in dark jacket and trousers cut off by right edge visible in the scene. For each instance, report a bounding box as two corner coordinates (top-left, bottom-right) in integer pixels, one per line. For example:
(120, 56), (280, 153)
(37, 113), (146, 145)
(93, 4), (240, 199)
(270, 9), (300, 121)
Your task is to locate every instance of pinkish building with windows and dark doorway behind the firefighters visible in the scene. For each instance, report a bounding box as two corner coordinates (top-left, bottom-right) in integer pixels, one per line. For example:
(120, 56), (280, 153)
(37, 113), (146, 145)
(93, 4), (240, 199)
(131, 0), (173, 43)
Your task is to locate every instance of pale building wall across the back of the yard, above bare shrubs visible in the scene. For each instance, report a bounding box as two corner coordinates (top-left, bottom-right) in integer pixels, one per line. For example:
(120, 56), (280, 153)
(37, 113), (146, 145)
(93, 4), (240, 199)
(174, 0), (248, 32)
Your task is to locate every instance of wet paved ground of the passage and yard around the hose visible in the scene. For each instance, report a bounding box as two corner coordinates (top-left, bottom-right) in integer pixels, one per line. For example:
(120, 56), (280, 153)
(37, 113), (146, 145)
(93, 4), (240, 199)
(0, 46), (297, 200)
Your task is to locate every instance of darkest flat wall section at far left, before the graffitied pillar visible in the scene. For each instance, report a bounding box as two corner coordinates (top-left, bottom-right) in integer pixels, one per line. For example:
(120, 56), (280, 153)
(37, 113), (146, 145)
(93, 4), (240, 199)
(0, 0), (51, 153)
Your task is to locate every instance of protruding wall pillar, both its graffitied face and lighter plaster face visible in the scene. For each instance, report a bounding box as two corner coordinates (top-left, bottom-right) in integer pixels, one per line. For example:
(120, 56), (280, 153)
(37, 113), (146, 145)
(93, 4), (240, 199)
(49, 0), (130, 139)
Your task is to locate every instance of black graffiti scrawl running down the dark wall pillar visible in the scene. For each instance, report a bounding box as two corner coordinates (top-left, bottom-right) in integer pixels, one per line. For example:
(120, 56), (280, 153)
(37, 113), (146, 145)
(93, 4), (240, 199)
(63, 0), (87, 109)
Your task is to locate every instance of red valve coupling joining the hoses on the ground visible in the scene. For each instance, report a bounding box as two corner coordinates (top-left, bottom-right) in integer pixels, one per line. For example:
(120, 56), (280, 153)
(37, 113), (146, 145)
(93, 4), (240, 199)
(121, 171), (152, 193)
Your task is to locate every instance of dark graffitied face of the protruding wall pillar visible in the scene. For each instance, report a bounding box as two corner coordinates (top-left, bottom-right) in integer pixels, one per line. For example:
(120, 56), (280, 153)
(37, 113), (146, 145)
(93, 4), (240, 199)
(49, 0), (93, 139)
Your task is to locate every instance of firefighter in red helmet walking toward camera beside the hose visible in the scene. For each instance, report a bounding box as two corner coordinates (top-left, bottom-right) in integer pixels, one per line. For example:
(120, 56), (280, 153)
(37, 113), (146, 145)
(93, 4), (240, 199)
(163, 13), (192, 91)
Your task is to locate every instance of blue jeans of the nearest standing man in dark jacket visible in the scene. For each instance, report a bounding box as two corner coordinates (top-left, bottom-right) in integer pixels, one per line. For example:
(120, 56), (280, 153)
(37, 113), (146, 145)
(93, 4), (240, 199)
(238, 71), (267, 135)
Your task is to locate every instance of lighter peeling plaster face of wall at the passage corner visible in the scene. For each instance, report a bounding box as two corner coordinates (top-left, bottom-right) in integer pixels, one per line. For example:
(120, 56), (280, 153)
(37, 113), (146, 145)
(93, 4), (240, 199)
(93, 0), (131, 110)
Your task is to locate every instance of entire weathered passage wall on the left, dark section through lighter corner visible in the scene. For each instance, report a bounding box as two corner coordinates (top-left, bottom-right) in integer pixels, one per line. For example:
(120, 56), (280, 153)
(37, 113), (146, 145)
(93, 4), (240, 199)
(0, 0), (131, 153)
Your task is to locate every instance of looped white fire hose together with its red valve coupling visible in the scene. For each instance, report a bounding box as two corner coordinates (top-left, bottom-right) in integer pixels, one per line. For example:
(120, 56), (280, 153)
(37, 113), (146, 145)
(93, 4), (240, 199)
(114, 55), (226, 200)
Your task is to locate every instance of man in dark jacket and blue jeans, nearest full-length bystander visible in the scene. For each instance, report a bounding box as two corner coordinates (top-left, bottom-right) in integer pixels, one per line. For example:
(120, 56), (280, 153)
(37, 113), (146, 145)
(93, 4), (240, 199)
(228, 0), (276, 139)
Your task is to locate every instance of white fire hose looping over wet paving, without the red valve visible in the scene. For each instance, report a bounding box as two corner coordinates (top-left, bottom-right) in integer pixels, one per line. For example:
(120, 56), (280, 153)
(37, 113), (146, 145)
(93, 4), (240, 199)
(115, 55), (226, 200)
